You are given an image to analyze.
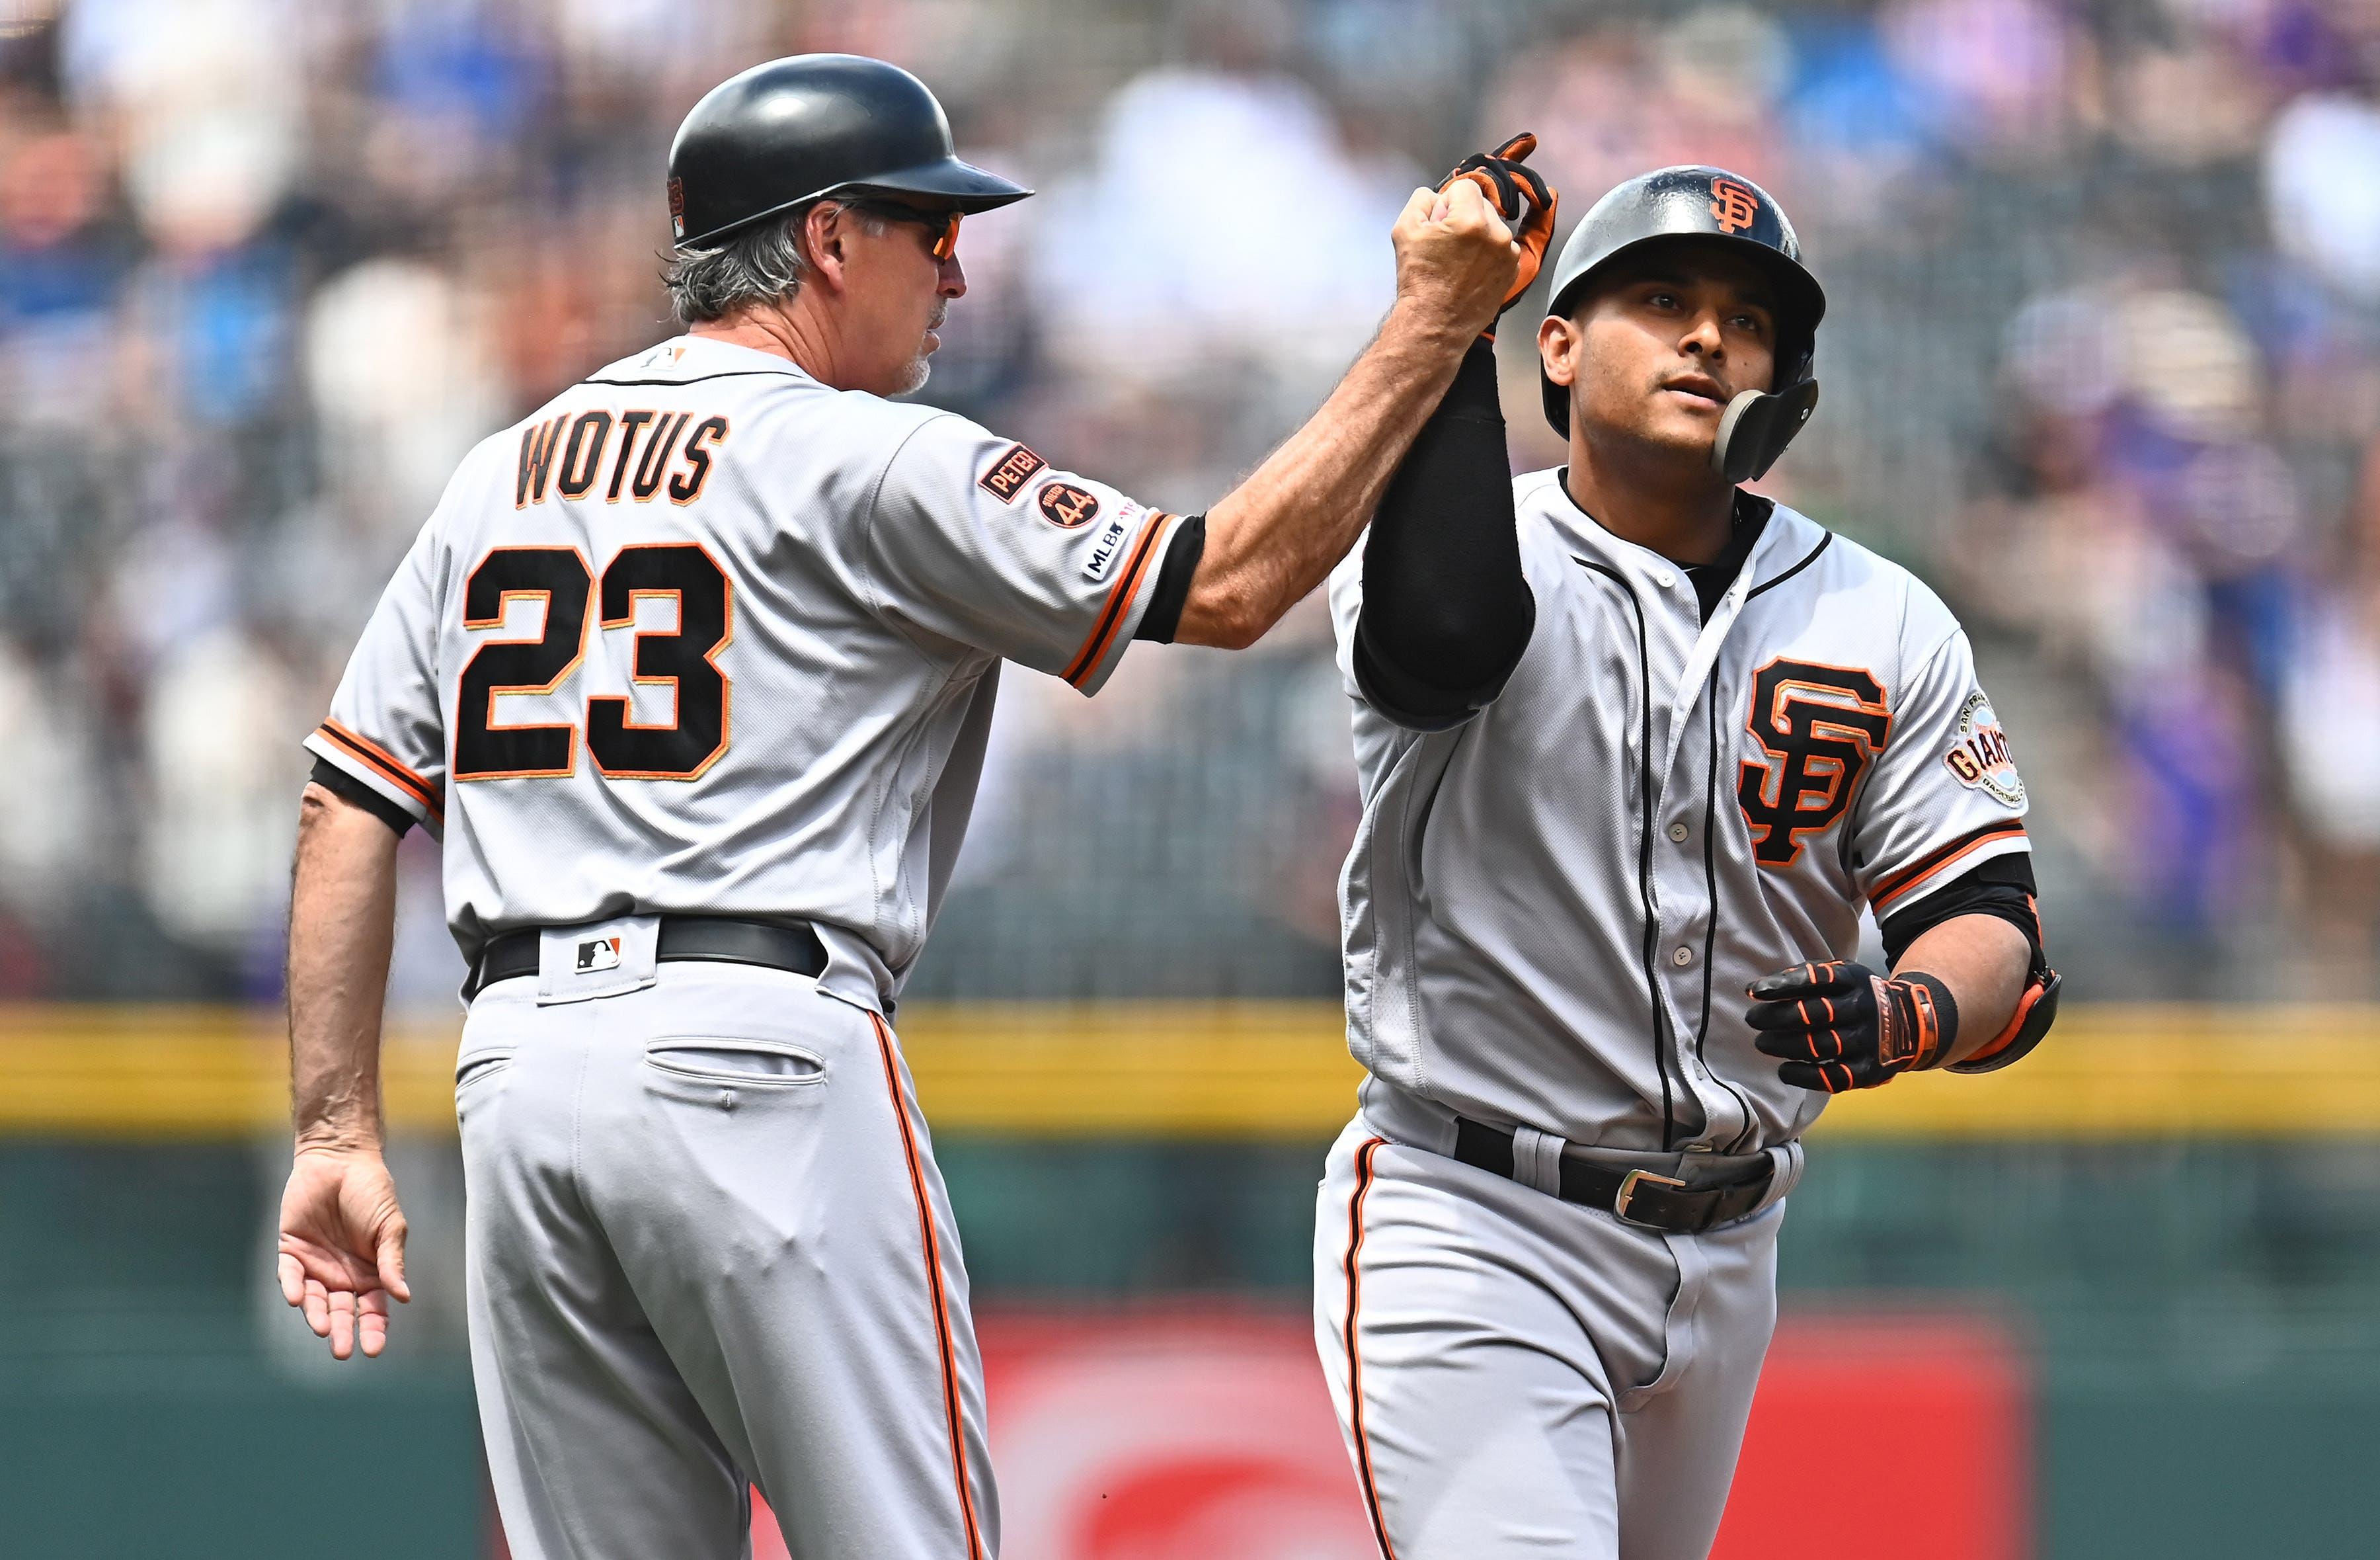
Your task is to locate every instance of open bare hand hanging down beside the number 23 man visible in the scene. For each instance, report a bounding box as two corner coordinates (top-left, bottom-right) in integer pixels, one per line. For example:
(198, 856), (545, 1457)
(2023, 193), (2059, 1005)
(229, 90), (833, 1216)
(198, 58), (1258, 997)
(278, 1145), (412, 1360)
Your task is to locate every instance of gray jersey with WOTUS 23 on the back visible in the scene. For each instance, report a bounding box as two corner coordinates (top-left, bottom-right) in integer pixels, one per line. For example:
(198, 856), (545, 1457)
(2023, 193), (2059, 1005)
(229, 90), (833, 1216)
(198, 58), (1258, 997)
(307, 336), (1175, 1007)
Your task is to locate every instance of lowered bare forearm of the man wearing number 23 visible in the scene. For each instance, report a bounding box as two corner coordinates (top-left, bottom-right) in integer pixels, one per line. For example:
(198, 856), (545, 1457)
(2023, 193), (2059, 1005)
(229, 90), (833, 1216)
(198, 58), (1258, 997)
(288, 786), (397, 1148)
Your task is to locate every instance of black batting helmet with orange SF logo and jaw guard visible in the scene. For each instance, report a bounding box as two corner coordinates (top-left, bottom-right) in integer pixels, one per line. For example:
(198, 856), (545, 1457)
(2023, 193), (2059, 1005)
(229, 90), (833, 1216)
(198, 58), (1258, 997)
(1538, 165), (1825, 481)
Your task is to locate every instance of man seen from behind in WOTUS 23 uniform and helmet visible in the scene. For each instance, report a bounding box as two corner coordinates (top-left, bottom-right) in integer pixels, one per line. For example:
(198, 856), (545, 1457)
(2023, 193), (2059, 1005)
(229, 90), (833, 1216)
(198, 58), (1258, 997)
(278, 55), (1552, 1560)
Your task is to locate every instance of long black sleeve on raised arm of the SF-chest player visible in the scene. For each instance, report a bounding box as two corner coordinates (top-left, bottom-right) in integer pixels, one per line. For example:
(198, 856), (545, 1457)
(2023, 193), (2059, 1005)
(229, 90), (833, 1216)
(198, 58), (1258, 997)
(1354, 338), (1538, 729)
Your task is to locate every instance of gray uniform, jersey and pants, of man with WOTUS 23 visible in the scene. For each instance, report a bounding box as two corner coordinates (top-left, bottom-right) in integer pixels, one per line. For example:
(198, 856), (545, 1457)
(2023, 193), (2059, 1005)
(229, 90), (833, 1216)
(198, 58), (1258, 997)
(307, 338), (1199, 1560)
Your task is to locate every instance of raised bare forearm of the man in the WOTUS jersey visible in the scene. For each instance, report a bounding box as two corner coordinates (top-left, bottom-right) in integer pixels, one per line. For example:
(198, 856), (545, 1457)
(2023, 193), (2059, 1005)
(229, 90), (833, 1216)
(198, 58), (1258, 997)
(1175, 298), (1478, 650)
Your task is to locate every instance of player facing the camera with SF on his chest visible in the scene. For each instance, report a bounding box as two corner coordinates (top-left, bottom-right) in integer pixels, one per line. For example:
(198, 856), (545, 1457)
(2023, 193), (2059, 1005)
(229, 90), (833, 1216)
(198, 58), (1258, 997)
(1314, 159), (2059, 1560)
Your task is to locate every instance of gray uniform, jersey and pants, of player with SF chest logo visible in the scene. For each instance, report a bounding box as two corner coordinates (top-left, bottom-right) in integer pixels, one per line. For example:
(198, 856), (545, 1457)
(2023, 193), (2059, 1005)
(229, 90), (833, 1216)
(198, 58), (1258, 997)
(1314, 472), (2026, 1560)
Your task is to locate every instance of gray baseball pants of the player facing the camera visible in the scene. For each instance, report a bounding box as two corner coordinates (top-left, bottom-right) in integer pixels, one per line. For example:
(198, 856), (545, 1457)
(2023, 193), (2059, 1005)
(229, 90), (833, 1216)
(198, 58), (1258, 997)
(1314, 1117), (1782, 1560)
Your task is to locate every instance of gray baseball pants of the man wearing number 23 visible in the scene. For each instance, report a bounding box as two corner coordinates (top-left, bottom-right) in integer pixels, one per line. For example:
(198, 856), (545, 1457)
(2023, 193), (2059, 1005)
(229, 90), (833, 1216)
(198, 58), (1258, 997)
(455, 962), (1000, 1560)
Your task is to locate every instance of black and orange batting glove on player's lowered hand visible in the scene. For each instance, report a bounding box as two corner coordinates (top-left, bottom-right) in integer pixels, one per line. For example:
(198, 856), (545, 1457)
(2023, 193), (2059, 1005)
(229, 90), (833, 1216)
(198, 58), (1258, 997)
(1745, 960), (1959, 1093)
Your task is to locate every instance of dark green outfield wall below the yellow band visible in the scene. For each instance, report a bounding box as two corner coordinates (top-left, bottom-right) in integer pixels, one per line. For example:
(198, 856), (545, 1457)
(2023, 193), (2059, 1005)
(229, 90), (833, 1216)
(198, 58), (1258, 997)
(0, 1014), (2380, 1560)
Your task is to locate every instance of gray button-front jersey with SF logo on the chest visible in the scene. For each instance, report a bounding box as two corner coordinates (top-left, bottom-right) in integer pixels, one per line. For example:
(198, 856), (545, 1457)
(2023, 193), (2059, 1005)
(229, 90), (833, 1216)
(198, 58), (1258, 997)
(1330, 472), (2028, 1155)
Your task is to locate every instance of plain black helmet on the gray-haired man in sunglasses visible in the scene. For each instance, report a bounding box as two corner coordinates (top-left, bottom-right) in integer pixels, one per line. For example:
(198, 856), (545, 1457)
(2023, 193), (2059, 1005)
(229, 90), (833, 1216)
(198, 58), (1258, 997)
(669, 55), (1033, 248)
